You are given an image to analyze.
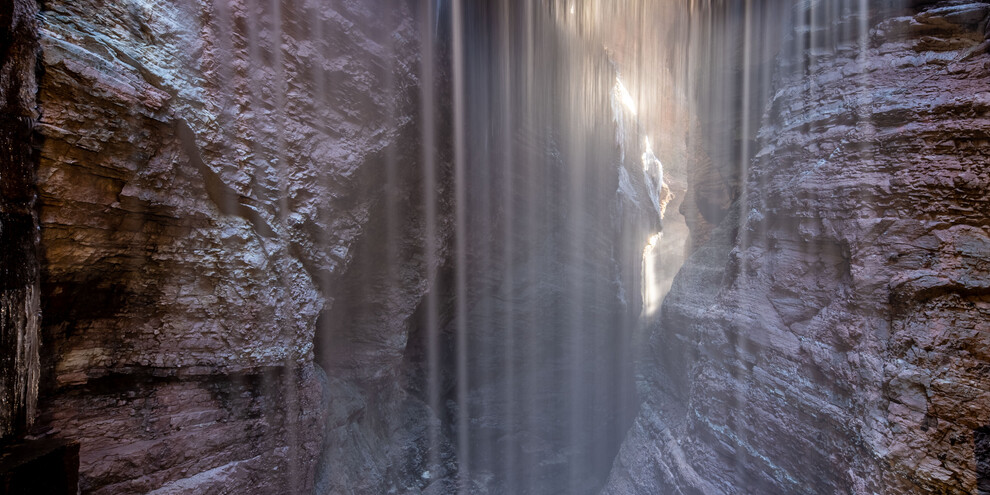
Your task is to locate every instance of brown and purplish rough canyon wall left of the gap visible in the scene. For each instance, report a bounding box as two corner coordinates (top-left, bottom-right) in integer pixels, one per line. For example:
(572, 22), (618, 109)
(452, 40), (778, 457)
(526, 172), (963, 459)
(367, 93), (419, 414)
(24, 1), (424, 493)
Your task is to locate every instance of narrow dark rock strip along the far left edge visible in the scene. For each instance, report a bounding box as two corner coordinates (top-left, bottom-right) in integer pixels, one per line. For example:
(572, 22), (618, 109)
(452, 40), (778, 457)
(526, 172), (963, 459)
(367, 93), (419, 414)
(0, 1), (40, 440)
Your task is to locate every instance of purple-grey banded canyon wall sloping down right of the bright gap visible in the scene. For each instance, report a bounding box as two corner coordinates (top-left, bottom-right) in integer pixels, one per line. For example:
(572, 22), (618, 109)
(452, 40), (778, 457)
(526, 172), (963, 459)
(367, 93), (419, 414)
(605, 1), (990, 494)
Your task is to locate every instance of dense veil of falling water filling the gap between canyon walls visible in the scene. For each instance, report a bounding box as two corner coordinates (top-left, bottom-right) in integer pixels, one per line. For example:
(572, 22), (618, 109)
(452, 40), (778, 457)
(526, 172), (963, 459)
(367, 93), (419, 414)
(194, 0), (908, 494)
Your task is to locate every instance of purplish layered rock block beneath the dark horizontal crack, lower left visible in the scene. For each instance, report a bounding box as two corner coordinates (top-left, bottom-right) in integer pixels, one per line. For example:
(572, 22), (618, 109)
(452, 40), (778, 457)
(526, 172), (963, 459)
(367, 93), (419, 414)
(41, 365), (325, 494)
